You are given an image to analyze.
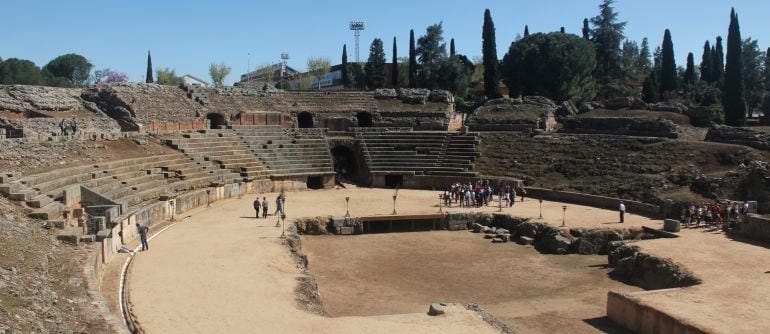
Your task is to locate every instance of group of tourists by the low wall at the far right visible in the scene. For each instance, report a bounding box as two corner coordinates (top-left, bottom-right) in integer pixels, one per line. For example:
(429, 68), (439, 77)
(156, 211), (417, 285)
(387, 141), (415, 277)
(681, 202), (750, 229)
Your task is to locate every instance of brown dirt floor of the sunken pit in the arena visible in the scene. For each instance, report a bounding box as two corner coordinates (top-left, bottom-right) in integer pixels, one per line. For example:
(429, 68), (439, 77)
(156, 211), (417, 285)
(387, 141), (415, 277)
(302, 231), (641, 333)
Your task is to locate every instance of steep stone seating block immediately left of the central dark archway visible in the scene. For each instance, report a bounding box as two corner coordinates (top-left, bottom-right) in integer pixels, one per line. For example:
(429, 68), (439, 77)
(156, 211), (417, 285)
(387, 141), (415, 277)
(230, 125), (334, 177)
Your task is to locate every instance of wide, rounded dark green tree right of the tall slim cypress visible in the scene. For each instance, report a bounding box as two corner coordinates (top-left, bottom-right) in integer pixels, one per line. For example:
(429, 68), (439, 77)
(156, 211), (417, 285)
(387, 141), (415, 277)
(501, 33), (596, 101)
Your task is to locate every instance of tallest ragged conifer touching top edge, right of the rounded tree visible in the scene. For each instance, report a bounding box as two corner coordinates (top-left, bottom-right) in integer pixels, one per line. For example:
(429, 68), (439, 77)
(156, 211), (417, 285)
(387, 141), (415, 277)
(591, 0), (626, 96)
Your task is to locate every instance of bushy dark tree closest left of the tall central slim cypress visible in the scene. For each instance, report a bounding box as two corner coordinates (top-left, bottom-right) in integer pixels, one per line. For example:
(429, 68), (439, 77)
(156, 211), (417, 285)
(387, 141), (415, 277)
(417, 22), (447, 89)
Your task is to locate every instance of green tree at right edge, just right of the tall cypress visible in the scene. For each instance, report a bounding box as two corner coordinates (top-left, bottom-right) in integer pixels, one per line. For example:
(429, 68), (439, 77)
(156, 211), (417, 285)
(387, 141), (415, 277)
(741, 38), (765, 111)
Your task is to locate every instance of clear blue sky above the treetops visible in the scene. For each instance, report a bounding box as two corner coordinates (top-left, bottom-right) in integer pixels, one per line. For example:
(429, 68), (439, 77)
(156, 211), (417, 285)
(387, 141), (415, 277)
(0, 0), (770, 84)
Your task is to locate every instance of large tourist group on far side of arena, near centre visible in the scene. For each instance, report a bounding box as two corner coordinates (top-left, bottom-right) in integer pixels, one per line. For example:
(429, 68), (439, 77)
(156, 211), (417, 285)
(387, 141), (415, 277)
(442, 180), (527, 208)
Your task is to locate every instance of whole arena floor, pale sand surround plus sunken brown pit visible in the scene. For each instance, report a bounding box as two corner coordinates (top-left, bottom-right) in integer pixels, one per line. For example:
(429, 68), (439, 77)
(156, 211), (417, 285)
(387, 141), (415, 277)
(128, 188), (659, 333)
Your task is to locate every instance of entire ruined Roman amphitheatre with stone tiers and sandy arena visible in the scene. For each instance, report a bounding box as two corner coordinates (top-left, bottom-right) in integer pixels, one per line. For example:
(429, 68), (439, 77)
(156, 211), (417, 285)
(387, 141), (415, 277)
(0, 84), (770, 333)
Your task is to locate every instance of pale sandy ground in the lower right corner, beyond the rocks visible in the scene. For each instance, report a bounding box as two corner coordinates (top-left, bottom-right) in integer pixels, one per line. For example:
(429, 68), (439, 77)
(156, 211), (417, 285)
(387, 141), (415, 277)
(616, 228), (770, 333)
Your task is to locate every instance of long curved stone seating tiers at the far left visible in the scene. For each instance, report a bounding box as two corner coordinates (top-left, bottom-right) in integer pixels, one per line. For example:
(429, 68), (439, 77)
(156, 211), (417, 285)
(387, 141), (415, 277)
(0, 153), (240, 219)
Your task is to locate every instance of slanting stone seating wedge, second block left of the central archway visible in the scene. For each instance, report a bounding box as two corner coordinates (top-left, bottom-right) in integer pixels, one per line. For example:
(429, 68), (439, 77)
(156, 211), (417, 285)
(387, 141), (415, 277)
(163, 129), (269, 181)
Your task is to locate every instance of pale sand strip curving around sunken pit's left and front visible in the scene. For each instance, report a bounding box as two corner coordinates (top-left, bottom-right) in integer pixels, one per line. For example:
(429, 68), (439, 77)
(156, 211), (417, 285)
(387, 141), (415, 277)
(128, 192), (508, 333)
